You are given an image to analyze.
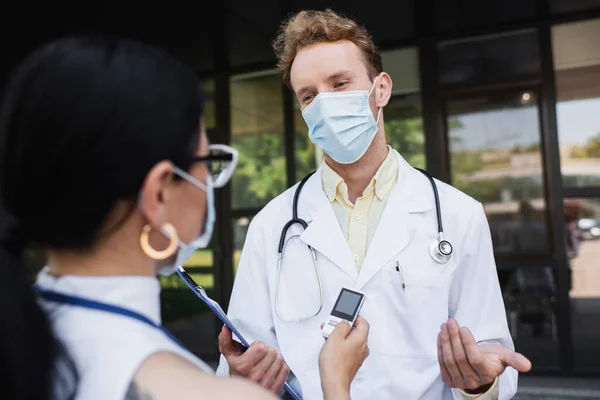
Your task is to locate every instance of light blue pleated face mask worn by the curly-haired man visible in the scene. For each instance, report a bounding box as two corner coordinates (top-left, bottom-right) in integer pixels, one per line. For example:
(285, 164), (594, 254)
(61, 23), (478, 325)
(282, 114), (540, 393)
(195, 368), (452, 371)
(302, 78), (381, 164)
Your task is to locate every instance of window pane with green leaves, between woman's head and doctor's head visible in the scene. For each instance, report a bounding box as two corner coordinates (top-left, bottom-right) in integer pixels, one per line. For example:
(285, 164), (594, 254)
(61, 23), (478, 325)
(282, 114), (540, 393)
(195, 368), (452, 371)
(231, 72), (287, 209)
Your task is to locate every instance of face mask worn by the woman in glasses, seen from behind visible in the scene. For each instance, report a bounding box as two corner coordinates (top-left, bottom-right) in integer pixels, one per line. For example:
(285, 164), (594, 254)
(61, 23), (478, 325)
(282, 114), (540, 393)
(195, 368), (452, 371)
(158, 167), (215, 276)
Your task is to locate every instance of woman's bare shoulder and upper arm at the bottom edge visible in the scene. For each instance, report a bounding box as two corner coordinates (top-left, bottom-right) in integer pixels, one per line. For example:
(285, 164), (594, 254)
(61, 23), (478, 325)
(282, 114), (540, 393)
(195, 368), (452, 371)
(126, 353), (275, 400)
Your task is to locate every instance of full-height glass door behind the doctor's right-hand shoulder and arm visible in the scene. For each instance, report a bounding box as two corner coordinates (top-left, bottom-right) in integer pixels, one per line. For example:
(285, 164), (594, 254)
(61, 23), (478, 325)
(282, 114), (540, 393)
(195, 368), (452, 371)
(445, 88), (558, 368)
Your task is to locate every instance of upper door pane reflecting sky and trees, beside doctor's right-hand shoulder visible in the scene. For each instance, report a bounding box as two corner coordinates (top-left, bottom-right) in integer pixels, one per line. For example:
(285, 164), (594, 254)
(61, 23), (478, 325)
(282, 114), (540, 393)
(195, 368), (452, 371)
(447, 91), (548, 256)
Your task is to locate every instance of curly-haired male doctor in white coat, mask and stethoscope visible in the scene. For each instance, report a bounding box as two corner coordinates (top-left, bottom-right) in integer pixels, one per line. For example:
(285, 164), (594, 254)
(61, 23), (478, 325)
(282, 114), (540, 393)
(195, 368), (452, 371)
(219, 10), (531, 400)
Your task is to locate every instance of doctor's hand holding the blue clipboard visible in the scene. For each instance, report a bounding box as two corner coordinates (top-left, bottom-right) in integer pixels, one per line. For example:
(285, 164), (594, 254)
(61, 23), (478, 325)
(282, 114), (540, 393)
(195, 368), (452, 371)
(219, 326), (290, 393)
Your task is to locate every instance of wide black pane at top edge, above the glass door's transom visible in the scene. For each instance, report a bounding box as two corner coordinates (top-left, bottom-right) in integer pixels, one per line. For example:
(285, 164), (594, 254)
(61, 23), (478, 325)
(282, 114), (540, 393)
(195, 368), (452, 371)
(434, 0), (536, 32)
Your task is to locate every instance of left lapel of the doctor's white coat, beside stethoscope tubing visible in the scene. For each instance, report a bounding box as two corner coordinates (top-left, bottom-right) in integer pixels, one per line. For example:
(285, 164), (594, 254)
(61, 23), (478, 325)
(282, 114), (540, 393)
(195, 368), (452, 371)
(298, 168), (358, 281)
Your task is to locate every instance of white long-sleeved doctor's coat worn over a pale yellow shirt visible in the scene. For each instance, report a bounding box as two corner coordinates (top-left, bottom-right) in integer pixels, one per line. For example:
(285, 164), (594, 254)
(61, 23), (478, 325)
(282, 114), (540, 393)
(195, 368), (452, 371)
(217, 153), (517, 400)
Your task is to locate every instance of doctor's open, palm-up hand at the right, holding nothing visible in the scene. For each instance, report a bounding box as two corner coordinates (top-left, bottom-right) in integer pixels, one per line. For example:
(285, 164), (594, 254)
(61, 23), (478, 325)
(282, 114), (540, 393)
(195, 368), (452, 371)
(438, 319), (531, 394)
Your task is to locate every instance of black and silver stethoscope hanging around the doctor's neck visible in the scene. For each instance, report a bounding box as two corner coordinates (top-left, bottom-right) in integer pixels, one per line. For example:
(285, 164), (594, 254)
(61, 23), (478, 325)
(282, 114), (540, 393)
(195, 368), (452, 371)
(275, 168), (453, 322)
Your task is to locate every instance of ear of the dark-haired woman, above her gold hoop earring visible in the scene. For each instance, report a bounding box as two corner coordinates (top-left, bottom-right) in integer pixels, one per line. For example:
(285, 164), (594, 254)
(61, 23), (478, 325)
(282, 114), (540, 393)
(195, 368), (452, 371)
(140, 161), (173, 230)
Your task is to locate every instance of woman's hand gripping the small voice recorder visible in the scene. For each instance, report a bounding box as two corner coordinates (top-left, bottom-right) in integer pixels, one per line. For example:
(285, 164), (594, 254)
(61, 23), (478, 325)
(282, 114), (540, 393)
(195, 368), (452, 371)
(319, 316), (369, 400)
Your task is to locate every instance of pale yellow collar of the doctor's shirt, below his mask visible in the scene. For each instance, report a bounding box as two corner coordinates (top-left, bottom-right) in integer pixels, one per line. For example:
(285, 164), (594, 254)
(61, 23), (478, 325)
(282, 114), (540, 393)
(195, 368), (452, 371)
(321, 146), (398, 203)
